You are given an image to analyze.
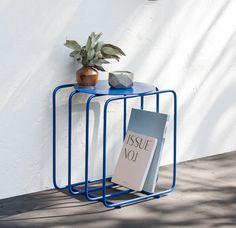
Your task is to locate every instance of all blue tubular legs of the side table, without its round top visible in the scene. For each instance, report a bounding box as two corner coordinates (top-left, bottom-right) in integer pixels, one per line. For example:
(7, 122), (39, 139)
(53, 84), (177, 208)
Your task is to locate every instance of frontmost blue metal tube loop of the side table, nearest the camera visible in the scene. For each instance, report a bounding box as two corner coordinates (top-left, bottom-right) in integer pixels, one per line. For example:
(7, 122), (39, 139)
(102, 90), (177, 208)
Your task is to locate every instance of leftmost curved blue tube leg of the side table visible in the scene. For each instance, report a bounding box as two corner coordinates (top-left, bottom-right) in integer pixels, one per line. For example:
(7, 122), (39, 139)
(52, 84), (74, 190)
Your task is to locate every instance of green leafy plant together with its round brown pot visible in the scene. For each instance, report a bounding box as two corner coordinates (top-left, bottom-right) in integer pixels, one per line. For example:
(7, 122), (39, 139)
(64, 32), (125, 87)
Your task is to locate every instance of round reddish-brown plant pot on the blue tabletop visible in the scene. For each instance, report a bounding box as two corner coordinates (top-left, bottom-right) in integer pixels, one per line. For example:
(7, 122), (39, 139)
(76, 67), (98, 87)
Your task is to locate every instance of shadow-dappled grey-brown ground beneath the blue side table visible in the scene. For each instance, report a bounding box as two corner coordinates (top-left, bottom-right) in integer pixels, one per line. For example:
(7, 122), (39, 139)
(0, 152), (236, 228)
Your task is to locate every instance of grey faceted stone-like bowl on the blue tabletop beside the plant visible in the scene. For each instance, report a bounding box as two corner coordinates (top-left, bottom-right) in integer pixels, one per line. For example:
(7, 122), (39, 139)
(108, 71), (134, 89)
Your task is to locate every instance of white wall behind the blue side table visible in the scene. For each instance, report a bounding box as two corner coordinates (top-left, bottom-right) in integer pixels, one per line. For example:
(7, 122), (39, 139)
(0, 0), (236, 198)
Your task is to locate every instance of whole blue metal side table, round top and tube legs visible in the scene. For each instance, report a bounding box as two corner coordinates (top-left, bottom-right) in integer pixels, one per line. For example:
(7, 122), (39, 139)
(52, 80), (177, 208)
